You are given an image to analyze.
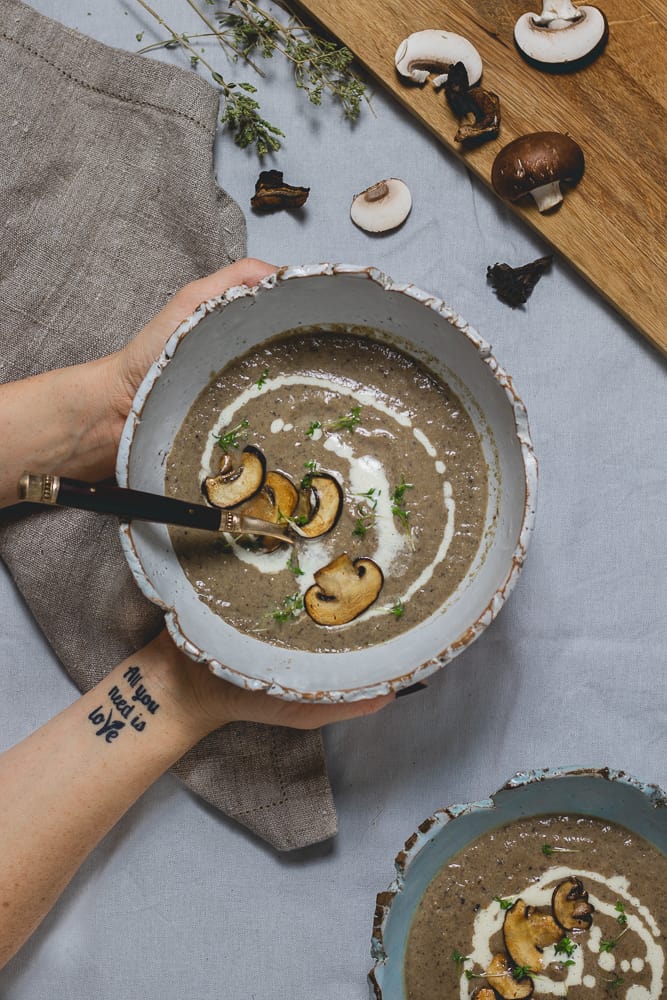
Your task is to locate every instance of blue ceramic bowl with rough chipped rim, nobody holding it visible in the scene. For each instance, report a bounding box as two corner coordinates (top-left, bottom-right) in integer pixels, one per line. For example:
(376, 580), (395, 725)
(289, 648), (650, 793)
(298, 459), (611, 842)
(369, 767), (667, 1000)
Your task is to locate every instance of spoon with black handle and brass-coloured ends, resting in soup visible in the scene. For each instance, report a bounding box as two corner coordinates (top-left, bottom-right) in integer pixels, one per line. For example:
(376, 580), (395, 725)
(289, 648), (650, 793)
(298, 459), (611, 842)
(18, 472), (294, 545)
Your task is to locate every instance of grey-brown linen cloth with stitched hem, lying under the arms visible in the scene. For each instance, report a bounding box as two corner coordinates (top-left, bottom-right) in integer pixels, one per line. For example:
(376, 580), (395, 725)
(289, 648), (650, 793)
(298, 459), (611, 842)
(0, 0), (336, 850)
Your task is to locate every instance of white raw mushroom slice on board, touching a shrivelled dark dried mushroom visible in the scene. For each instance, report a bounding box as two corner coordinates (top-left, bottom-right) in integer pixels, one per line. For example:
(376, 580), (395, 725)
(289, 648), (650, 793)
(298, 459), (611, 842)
(394, 28), (482, 87)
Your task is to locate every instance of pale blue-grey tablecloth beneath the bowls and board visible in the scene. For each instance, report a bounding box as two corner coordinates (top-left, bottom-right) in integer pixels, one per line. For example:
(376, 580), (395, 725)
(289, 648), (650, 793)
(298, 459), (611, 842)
(0, 0), (667, 1000)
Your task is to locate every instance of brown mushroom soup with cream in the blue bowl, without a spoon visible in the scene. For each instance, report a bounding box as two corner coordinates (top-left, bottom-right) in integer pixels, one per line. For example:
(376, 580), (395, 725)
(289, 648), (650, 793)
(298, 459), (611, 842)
(404, 816), (667, 1000)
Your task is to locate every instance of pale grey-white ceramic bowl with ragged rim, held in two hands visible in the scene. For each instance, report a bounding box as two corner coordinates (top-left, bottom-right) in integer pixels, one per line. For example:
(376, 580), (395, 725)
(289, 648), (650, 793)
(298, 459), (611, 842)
(117, 264), (537, 702)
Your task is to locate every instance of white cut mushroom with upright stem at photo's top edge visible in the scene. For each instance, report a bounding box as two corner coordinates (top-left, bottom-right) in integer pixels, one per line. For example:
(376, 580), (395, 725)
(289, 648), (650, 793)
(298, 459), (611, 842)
(514, 0), (607, 71)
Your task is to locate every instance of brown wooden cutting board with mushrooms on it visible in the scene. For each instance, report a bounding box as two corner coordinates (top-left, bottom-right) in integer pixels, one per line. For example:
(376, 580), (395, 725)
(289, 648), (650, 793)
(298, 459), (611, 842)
(294, 0), (667, 354)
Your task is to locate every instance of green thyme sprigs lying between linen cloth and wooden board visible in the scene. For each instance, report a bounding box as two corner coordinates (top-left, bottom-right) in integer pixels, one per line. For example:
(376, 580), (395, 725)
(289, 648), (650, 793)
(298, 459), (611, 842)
(136, 0), (370, 159)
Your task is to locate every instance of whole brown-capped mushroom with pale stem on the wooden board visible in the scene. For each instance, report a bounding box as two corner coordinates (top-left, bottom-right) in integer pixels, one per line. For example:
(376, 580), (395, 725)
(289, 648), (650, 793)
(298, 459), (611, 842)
(491, 132), (584, 212)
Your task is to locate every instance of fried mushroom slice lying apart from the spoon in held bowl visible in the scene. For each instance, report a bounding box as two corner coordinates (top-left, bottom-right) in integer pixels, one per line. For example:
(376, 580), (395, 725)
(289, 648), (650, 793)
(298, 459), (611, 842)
(303, 552), (384, 625)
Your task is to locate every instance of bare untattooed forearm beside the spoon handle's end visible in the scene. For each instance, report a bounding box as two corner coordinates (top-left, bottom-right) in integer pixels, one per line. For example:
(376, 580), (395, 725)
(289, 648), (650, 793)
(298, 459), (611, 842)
(0, 356), (123, 507)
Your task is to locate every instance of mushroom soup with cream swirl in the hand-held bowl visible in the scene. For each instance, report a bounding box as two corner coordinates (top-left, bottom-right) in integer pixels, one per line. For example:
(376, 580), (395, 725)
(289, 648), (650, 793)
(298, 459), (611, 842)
(165, 329), (488, 652)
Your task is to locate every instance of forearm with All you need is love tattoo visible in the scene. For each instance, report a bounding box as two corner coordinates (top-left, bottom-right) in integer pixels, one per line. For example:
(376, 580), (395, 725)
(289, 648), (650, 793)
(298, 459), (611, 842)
(0, 636), (213, 967)
